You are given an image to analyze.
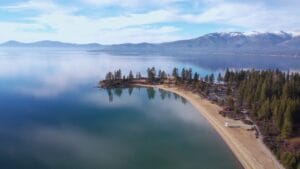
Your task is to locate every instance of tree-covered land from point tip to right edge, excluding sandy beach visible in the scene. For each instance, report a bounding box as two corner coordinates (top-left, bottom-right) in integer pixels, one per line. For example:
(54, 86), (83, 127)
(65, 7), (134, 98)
(100, 67), (300, 169)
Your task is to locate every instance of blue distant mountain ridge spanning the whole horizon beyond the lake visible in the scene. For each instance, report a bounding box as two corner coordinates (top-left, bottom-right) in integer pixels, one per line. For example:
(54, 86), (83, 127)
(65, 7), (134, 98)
(0, 31), (300, 56)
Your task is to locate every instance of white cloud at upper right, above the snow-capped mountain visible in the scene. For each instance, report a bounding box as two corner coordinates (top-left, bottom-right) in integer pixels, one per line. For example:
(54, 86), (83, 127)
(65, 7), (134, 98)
(182, 3), (300, 31)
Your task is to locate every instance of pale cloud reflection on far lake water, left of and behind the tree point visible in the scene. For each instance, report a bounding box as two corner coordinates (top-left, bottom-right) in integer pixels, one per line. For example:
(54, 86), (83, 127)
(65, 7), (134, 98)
(0, 49), (217, 98)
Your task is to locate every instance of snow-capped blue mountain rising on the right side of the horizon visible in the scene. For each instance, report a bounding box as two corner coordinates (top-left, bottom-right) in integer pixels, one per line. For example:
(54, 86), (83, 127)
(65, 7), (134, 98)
(163, 32), (294, 50)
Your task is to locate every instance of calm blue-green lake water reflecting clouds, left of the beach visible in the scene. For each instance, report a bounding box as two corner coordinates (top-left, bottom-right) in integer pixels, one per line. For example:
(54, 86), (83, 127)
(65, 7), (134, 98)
(0, 49), (241, 169)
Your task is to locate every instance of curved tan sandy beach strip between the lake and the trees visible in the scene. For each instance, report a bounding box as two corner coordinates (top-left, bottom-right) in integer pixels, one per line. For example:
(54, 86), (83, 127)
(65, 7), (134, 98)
(134, 84), (284, 169)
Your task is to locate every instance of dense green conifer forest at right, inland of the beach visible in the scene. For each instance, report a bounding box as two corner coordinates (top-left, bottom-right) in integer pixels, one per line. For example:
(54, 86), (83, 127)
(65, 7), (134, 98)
(224, 70), (300, 169)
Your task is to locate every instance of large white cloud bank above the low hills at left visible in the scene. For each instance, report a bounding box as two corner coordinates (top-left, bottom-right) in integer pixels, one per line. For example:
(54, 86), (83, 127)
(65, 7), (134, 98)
(0, 1), (178, 43)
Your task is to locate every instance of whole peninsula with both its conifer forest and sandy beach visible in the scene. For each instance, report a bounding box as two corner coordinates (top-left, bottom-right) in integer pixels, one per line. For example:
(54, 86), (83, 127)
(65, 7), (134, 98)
(99, 67), (300, 169)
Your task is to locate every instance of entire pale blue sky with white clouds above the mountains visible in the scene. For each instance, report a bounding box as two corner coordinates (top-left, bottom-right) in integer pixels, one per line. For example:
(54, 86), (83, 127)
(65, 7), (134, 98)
(0, 0), (300, 44)
